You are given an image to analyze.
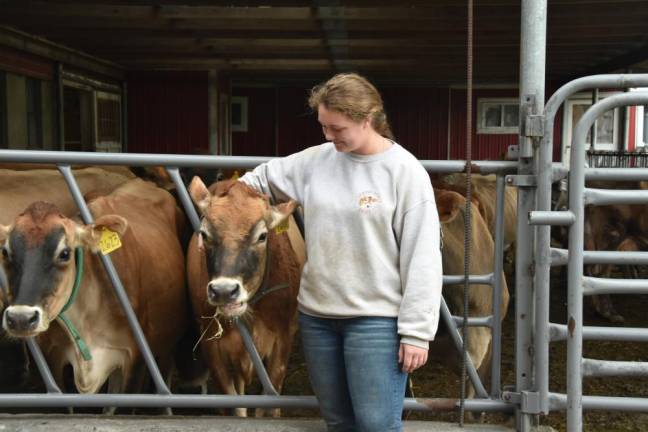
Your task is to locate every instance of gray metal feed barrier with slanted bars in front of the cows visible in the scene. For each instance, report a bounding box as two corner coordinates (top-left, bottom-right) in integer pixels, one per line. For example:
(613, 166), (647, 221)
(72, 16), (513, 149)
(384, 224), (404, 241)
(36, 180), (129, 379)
(0, 150), (516, 412)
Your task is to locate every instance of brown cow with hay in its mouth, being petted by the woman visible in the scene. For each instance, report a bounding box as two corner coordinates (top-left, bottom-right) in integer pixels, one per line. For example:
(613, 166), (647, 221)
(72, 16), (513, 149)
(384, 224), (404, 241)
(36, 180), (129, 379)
(187, 177), (303, 416)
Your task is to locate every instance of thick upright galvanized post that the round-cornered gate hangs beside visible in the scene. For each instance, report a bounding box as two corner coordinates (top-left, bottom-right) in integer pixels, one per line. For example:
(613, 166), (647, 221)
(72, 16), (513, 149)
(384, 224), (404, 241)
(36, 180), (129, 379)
(515, 0), (547, 432)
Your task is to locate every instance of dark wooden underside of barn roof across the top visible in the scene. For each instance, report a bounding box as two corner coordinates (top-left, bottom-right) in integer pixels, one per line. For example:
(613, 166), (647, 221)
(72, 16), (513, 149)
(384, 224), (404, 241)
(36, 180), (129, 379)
(0, 0), (648, 85)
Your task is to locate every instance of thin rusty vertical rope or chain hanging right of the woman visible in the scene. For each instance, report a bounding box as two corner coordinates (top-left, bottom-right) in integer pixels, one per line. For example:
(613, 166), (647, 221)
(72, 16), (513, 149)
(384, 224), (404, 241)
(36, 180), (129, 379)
(459, 0), (473, 427)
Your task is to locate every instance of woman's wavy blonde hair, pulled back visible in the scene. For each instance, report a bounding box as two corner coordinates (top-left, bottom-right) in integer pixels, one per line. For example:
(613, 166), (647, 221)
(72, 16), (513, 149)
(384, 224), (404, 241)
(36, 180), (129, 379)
(308, 73), (394, 139)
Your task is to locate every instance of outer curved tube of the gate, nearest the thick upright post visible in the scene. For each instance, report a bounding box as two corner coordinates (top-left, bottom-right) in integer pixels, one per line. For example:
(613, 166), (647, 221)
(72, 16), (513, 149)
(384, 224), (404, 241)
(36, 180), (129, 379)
(534, 74), (648, 426)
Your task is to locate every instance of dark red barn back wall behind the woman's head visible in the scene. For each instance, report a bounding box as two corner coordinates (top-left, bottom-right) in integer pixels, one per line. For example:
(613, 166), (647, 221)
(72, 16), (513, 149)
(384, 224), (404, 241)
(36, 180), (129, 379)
(232, 83), (562, 160)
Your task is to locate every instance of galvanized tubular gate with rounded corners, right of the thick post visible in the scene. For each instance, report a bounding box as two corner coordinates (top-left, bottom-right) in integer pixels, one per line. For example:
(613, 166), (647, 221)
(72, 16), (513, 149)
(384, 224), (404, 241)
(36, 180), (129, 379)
(519, 75), (648, 432)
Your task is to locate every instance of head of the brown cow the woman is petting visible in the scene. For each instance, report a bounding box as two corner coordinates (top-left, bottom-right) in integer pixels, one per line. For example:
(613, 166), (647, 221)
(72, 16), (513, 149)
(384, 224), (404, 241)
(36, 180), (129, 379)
(189, 177), (296, 318)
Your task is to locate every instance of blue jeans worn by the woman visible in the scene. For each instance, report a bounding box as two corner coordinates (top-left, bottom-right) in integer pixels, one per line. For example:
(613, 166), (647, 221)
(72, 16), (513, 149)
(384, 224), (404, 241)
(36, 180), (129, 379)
(299, 312), (407, 432)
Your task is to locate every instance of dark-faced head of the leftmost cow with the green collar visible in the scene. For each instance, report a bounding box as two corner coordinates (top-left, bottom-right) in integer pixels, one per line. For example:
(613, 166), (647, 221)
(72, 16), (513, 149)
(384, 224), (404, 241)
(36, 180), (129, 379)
(0, 202), (126, 337)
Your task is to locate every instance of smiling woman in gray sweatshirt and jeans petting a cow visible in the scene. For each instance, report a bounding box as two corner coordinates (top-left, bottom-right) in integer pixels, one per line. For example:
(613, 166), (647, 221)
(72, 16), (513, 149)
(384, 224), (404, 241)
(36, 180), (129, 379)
(241, 74), (442, 432)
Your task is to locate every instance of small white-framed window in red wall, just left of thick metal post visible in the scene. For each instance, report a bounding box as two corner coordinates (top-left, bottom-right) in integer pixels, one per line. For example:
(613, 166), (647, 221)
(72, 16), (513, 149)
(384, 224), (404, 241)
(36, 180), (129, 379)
(477, 99), (520, 134)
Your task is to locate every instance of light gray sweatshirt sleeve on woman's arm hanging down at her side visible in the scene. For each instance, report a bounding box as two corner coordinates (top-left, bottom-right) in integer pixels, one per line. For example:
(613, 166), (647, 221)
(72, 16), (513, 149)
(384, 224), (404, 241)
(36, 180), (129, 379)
(398, 181), (443, 348)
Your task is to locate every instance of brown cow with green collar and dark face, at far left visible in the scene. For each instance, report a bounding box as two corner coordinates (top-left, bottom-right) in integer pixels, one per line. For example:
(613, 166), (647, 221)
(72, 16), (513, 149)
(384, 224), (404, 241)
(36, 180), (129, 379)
(0, 179), (187, 393)
